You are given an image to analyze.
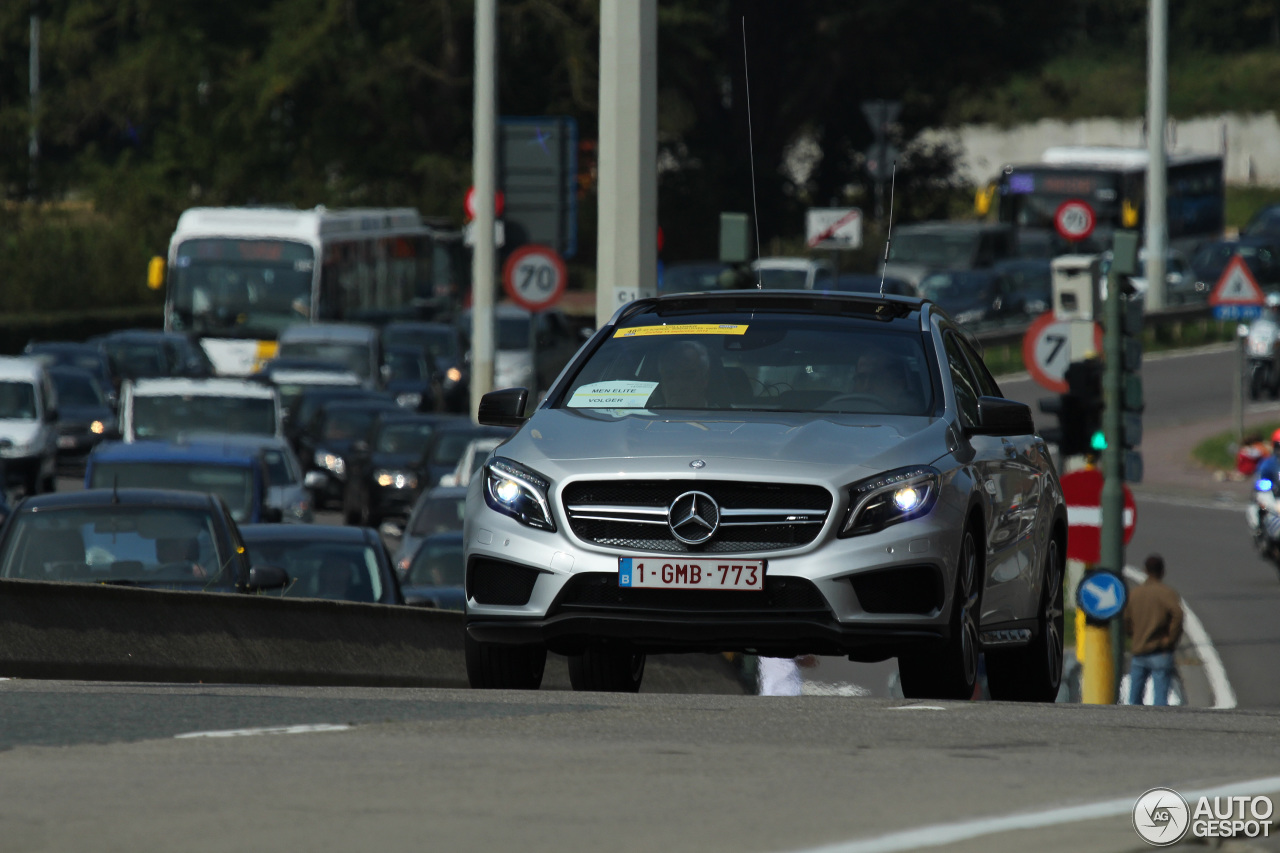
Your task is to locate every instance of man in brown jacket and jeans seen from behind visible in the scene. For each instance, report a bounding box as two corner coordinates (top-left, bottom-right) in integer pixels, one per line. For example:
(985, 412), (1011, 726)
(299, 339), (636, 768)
(1124, 553), (1183, 704)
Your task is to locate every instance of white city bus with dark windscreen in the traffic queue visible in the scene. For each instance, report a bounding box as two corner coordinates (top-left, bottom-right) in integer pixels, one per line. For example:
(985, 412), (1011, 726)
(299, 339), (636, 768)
(151, 206), (457, 375)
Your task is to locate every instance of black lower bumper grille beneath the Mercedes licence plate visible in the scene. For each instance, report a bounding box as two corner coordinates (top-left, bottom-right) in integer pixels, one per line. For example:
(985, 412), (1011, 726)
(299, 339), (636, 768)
(549, 571), (831, 619)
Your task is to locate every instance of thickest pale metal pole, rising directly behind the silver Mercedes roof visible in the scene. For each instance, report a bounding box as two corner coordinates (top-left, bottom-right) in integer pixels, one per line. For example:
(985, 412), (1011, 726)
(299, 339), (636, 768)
(595, 0), (658, 325)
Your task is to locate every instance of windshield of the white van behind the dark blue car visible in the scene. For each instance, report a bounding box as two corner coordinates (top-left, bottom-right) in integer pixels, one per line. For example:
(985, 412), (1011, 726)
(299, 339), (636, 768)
(133, 394), (275, 439)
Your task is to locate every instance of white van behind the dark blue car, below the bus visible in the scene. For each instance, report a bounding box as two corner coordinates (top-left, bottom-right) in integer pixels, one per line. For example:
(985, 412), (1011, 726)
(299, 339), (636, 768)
(120, 379), (284, 442)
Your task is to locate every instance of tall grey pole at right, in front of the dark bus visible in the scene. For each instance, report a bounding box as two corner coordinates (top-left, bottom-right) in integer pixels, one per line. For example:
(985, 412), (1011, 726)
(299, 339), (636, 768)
(1146, 0), (1169, 310)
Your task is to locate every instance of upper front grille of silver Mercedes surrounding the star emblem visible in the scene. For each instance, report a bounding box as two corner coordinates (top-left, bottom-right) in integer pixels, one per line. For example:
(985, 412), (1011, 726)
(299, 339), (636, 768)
(561, 480), (832, 553)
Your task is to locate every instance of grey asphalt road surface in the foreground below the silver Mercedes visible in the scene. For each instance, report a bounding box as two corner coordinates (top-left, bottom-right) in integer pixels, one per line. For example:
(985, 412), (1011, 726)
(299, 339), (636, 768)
(0, 681), (1280, 853)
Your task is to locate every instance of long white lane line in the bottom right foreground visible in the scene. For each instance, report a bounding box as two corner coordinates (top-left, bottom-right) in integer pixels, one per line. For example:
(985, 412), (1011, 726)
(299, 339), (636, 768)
(796, 776), (1280, 853)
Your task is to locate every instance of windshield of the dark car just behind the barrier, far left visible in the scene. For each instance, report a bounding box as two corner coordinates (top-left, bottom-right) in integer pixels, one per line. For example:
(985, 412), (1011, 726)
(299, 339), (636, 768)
(0, 505), (227, 589)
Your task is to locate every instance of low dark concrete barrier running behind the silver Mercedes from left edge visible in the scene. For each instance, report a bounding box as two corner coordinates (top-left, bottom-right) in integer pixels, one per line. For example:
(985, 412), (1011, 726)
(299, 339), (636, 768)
(0, 580), (745, 693)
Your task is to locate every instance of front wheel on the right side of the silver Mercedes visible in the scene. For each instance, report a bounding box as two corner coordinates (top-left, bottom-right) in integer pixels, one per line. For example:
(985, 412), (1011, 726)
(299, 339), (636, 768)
(897, 526), (987, 699)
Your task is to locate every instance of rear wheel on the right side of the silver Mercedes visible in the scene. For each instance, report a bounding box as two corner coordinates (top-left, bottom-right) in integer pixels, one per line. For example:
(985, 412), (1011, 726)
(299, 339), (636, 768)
(987, 539), (1065, 702)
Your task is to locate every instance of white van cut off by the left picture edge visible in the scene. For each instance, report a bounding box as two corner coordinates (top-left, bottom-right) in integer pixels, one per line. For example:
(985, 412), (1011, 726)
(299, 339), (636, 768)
(0, 357), (58, 494)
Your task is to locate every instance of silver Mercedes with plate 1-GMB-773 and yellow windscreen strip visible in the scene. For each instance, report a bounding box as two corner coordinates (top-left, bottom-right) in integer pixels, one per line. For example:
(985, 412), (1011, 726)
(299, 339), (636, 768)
(465, 291), (1066, 701)
